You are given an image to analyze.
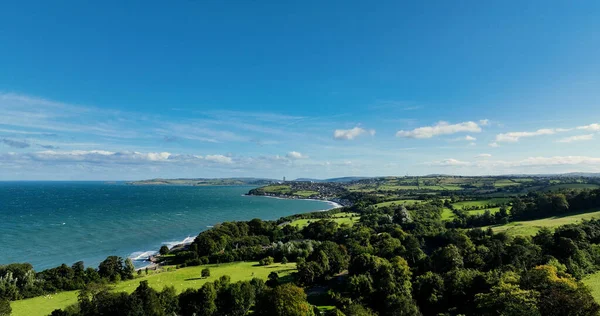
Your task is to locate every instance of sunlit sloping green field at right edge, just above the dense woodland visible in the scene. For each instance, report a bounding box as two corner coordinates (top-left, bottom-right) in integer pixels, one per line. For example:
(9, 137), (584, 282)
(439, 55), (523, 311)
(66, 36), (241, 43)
(492, 210), (600, 236)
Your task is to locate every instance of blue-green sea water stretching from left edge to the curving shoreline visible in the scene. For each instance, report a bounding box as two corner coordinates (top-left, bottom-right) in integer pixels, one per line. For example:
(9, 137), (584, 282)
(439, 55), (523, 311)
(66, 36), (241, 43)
(0, 182), (329, 270)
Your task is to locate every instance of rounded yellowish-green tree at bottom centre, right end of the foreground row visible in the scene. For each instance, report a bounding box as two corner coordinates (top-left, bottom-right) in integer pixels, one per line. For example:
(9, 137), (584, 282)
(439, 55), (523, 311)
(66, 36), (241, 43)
(255, 283), (314, 316)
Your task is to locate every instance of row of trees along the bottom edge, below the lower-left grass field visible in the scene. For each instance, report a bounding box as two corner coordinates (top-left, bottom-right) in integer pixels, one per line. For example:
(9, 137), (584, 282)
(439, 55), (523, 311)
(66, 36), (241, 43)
(51, 274), (314, 316)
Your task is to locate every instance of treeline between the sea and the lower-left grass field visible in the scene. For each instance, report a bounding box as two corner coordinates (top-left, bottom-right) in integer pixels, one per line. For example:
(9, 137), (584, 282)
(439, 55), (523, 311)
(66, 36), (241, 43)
(0, 256), (135, 301)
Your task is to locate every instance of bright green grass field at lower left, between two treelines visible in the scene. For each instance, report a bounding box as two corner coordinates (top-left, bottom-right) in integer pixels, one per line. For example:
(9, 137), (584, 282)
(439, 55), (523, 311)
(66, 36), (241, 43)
(11, 262), (296, 316)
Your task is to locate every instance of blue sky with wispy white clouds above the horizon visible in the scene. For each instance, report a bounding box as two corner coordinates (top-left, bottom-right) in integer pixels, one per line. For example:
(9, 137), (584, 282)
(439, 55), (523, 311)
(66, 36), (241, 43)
(0, 0), (600, 180)
